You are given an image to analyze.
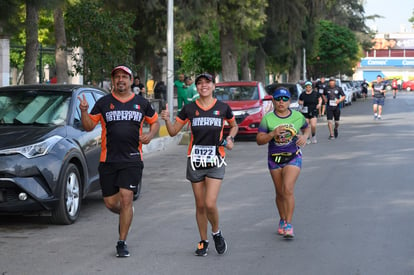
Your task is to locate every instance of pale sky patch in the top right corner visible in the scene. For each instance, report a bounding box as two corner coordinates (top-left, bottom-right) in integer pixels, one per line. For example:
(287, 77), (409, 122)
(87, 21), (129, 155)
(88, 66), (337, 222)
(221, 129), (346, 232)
(364, 0), (414, 33)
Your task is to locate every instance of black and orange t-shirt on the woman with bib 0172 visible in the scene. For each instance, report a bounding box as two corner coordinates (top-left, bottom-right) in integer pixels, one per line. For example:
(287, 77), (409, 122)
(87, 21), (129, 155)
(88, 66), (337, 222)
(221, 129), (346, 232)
(176, 99), (235, 157)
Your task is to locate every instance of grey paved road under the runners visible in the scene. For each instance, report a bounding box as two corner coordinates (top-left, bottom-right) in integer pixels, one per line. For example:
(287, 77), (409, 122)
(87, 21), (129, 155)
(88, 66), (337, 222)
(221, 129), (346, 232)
(0, 93), (414, 275)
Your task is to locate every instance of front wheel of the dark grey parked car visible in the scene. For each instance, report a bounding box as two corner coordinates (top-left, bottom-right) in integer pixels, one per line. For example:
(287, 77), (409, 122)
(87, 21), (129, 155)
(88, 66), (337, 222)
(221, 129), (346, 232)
(51, 163), (82, 224)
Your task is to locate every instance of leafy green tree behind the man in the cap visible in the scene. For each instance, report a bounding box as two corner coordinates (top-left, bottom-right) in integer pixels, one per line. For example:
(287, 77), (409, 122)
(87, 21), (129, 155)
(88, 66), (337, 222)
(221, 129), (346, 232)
(65, 1), (136, 82)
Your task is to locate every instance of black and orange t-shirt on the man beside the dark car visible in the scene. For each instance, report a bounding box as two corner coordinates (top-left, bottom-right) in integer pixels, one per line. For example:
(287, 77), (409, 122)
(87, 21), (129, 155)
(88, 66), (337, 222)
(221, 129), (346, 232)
(90, 94), (158, 162)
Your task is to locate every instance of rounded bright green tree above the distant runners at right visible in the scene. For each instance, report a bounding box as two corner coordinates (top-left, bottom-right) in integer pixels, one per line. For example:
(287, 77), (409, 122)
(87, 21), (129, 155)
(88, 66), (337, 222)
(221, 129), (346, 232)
(310, 20), (358, 75)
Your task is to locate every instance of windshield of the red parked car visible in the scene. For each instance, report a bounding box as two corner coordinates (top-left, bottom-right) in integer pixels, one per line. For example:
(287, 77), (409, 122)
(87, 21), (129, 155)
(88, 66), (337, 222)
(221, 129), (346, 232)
(214, 86), (259, 101)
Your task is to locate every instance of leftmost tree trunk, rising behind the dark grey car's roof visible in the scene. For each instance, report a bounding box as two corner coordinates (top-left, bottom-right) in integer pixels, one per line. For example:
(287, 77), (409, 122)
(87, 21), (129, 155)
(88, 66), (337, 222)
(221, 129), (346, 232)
(23, 0), (39, 84)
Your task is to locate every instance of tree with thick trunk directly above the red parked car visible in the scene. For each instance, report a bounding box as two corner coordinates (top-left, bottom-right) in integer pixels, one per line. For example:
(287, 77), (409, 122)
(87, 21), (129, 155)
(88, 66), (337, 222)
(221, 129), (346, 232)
(177, 0), (267, 81)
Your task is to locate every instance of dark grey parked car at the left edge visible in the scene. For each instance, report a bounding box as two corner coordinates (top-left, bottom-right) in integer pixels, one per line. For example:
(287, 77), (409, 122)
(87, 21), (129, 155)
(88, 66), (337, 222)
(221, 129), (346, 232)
(0, 85), (111, 224)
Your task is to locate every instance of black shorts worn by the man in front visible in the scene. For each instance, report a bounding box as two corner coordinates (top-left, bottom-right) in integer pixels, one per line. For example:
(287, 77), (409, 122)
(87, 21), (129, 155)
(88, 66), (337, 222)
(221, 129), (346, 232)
(98, 161), (144, 197)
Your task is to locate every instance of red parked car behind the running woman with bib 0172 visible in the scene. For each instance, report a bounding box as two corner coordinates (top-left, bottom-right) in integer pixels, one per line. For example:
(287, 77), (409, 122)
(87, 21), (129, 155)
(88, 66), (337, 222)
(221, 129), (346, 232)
(214, 81), (273, 135)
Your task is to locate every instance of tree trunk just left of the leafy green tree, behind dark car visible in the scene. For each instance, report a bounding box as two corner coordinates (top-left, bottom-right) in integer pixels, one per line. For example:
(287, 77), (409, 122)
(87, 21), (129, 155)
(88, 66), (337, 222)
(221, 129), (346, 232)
(53, 7), (69, 83)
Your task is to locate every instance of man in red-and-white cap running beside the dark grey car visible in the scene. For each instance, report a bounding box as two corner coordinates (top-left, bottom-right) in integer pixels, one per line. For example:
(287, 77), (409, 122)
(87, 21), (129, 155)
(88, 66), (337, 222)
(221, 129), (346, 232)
(79, 66), (160, 257)
